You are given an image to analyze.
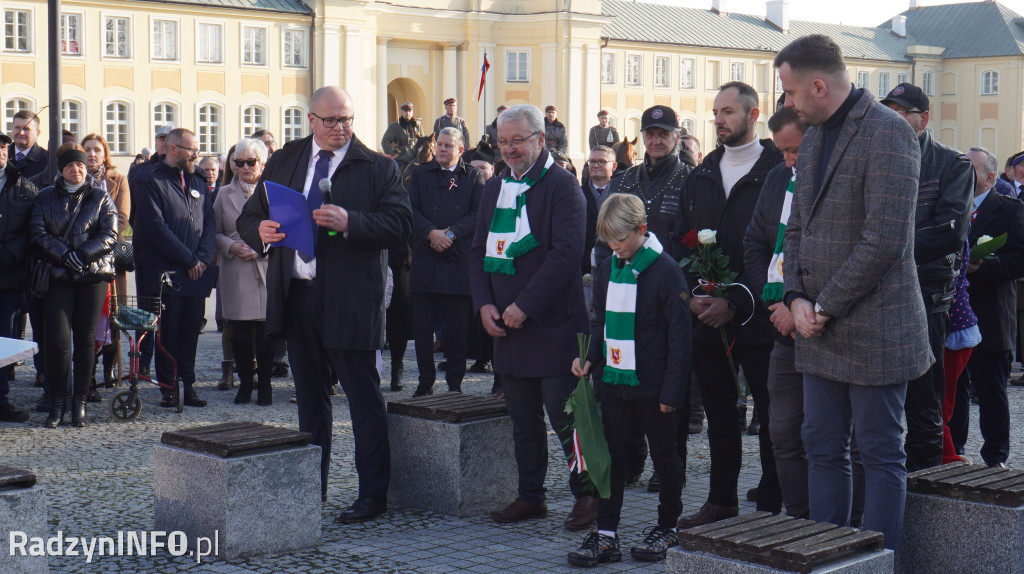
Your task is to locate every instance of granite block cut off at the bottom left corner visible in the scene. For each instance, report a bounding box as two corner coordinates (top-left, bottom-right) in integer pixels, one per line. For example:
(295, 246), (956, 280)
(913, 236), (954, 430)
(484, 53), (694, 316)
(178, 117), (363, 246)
(0, 486), (49, 574)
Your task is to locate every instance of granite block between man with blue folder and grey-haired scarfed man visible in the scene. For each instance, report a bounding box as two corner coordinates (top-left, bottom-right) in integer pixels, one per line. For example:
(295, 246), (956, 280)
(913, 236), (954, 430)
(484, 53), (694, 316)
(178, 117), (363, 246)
(388, 413), (519, 517)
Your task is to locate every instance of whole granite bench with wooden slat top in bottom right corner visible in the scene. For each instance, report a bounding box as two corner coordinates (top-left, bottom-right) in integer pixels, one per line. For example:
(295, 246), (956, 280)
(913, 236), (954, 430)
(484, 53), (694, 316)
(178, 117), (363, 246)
(896, 462), (1024, 574)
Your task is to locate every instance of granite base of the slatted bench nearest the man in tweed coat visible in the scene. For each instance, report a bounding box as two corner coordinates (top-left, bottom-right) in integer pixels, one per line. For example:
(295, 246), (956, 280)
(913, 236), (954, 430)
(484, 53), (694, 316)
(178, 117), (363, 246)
(666, 546), (892, 574)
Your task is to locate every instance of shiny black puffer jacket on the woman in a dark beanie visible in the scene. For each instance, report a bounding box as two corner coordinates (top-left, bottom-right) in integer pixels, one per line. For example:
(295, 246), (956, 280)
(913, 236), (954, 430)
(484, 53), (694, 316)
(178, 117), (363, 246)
(29, 176), (118, 283)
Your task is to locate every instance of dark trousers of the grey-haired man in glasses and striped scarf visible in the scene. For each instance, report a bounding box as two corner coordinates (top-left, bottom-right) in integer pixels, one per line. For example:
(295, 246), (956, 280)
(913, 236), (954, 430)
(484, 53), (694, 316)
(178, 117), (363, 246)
(502, 373), (583, 504)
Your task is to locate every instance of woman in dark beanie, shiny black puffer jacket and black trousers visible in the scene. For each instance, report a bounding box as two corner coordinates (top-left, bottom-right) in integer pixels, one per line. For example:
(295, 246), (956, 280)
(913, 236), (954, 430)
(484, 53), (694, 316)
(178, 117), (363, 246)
(29, 143), (118, 429)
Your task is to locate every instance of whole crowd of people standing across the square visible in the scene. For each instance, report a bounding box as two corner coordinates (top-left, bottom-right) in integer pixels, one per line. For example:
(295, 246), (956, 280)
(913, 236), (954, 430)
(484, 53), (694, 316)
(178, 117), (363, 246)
(0, 30), (1024, 566)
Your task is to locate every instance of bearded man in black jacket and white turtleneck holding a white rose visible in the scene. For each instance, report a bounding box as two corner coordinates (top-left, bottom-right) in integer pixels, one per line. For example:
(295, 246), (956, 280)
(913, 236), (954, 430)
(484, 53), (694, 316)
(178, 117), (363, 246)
(674, 82), (782, 528)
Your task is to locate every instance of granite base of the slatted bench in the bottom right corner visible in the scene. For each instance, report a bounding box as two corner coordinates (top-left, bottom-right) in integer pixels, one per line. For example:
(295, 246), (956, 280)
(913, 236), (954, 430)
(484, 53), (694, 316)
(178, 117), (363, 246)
(896, 492), (1024, 574)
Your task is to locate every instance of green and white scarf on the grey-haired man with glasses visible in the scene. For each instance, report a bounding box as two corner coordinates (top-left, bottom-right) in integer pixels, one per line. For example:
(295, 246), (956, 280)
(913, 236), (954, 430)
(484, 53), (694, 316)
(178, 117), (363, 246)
(483, 153), (555, 275)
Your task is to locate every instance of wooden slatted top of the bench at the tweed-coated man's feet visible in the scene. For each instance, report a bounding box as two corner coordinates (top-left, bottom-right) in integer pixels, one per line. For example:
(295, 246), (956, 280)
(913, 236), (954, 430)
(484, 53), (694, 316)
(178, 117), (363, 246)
(679, 512), (884, 574)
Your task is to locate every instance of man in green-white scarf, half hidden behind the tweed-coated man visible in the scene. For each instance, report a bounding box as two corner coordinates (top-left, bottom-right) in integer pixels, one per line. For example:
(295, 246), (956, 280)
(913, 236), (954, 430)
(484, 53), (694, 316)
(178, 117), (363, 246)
(743, 108), (809, 518)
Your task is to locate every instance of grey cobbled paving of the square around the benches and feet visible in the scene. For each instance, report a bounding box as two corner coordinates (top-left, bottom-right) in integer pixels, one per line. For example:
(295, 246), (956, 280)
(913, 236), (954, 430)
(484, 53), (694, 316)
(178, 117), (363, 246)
(0, 299), (1024, 573)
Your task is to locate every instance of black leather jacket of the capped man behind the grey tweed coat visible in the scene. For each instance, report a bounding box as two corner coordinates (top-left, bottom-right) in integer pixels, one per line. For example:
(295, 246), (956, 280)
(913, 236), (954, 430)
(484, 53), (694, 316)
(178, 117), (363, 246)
(913, 131), (975, 313)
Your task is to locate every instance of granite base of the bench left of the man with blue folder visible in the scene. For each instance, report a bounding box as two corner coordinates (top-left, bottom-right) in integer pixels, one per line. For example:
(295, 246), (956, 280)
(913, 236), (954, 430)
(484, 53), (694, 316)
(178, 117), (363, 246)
(153, 444), (321, 559)
